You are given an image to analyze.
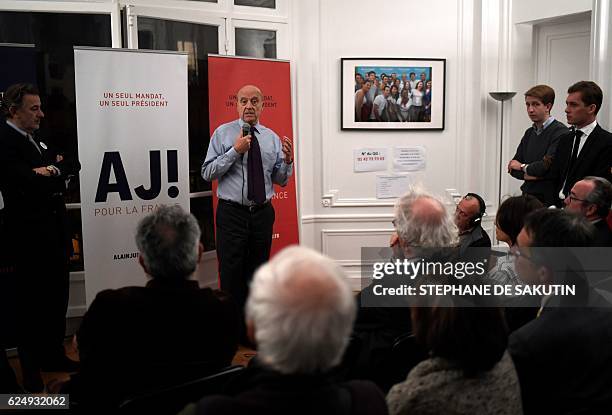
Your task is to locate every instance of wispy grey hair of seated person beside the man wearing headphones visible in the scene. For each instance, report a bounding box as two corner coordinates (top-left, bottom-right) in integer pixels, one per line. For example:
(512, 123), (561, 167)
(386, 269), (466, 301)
(394, 189), (459, 254)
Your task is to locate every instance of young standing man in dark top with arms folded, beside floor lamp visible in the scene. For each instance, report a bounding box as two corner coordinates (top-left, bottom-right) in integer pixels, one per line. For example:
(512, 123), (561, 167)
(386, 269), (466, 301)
(508, 85), (569, 206)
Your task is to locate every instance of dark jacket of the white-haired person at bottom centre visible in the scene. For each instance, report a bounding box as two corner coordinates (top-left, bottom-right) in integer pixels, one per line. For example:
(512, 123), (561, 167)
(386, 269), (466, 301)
(190, 359), (388, 415)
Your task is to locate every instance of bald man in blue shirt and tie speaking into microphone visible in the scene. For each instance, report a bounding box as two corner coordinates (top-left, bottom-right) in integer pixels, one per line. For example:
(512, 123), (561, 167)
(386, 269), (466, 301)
(202, 85), (293, 334)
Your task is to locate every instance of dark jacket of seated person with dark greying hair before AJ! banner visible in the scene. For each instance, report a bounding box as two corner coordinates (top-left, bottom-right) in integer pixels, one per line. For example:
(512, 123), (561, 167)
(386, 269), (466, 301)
(69, 279), (239, 405)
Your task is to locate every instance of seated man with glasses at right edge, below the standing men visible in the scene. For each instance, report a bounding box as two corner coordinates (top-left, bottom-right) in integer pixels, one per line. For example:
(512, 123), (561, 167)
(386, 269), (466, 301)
(565, 176), (612, 246)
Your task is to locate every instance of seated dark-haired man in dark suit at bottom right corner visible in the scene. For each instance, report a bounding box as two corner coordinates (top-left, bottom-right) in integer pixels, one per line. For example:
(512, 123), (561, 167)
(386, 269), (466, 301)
(508, 209), (612, 414)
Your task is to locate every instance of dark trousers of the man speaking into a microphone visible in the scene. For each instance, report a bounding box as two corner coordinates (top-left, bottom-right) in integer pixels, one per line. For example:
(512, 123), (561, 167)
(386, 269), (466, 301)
(216, 200), (275, 332)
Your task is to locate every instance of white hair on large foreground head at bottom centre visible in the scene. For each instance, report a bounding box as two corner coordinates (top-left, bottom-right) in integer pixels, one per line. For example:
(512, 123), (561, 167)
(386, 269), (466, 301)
(246, 246), (356, 374)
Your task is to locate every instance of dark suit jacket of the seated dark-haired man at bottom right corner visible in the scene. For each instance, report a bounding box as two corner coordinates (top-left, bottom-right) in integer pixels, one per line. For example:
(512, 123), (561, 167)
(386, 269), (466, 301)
(508, 290), (612, 415)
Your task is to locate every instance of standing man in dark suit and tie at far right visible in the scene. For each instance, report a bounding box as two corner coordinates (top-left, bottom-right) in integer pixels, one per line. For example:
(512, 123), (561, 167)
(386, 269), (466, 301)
(553, 81), (612, 207)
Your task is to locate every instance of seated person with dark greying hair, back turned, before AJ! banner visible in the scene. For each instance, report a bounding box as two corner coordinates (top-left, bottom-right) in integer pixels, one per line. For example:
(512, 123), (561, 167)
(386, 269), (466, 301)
(64, 206), (239, 407)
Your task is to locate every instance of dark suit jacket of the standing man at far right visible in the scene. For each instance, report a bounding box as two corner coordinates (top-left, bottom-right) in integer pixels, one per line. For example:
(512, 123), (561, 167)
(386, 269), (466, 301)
(552, 124), (612, 206)
